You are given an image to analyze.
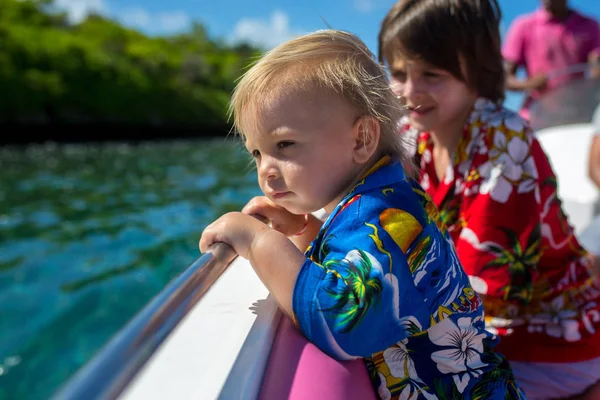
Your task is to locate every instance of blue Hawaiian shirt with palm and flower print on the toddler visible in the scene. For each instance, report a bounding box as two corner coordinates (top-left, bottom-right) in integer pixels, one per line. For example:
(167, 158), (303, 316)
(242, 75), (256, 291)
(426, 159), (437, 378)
(293, 157), (525, 399)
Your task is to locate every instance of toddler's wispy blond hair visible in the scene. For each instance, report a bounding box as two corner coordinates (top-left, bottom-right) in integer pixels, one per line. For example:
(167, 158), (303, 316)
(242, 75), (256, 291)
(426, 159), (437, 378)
(229, 30), (410, 166)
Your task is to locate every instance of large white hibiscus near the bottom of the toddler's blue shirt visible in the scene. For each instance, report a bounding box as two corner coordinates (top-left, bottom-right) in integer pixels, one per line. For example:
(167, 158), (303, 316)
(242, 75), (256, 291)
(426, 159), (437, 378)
(428, 317), (487, 393)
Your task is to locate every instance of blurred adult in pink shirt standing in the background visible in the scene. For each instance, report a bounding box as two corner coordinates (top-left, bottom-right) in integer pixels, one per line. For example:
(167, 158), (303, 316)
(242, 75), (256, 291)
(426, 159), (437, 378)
(502, 0), (600, 119)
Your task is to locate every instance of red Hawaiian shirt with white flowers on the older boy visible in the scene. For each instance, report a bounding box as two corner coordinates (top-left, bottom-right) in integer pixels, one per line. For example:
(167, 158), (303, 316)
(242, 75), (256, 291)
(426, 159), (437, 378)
(401, 99), (600, 362)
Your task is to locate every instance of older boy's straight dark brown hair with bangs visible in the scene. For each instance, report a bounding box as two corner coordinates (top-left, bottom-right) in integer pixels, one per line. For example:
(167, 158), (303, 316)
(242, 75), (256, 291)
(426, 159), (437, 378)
(378, 0), (505, 102)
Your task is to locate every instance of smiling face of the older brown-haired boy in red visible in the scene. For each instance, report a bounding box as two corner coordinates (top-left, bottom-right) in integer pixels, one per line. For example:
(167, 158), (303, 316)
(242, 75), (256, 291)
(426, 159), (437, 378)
(390, 58), (477, 133)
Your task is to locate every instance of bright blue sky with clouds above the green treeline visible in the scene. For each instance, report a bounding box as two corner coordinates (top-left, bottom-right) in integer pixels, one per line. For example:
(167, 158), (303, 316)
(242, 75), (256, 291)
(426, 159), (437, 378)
(55, 0), (600, 109)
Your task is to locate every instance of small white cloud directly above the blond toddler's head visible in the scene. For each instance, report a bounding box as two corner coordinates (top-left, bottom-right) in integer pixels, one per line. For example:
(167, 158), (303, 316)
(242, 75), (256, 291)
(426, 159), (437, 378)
(230, 11), (302, 48)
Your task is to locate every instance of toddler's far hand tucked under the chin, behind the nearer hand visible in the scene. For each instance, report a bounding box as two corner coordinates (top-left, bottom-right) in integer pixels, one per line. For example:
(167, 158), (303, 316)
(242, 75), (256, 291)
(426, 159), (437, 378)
(242, 196), (305, 236)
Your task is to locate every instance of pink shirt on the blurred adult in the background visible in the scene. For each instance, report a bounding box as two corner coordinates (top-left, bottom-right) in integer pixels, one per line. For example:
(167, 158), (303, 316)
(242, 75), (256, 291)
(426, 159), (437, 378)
(502, 8), (600, 119)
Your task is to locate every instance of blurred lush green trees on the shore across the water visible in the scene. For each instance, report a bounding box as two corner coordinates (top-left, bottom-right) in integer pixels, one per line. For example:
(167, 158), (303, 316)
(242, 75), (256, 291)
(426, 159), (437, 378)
(0, 0), (258, 127)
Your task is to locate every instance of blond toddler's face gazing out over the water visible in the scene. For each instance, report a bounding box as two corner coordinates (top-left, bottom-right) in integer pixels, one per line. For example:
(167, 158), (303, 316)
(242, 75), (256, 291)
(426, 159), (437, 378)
(246, 91), (362, 214)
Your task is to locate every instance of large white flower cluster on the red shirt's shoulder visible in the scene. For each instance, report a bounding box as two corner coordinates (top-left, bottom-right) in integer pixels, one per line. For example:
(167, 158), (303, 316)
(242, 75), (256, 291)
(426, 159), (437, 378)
(479, 130), (538, 203)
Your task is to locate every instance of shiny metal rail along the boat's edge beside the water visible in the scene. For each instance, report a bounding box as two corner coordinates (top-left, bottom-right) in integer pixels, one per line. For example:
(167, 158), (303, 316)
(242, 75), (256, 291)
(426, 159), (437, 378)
(53, 243), (237, 400)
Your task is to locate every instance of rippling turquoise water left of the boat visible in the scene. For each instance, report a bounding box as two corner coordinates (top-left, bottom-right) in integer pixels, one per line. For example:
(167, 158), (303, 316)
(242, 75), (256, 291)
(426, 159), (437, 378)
(0, 139), (259, 399)
